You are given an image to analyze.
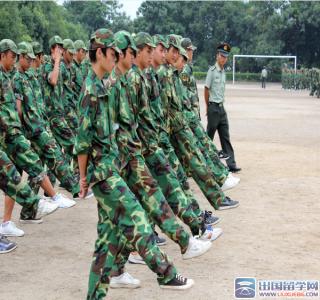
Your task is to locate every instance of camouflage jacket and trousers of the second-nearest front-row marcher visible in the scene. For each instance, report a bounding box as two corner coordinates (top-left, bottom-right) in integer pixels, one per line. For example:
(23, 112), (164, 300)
(106, 68), (189, 253)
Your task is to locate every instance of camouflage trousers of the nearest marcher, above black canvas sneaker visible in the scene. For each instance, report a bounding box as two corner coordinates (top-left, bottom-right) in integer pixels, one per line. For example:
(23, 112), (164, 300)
(87, 175), (177, 300)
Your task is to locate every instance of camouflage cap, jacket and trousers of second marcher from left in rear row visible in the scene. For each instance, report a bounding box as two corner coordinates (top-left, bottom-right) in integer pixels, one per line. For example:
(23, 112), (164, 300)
(13, 42), (80, 195)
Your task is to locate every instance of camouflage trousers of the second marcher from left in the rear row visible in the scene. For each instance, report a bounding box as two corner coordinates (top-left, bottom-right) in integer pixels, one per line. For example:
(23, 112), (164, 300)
(30, 131), (80, 195)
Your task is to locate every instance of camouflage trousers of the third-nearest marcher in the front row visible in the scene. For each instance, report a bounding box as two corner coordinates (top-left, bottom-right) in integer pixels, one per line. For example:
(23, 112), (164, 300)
(144, 148), (201, 235)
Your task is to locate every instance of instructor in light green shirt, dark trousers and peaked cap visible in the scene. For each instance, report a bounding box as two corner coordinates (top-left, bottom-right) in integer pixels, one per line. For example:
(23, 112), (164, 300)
(204, 43), (241, 173)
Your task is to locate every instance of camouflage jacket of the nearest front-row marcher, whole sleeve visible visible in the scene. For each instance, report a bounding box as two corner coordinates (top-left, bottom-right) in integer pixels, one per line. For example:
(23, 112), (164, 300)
(74, 70), (120, 183)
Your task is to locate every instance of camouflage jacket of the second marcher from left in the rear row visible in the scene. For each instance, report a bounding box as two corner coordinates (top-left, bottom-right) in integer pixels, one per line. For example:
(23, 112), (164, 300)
(12, 71), (46, 138)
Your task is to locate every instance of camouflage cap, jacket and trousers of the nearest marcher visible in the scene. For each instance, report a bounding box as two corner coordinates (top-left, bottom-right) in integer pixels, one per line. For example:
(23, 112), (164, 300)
(75, 29), (176, 299)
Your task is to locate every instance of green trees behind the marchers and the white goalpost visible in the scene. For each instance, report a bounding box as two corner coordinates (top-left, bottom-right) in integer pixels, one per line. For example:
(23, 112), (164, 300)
(0, 0), (320, 72)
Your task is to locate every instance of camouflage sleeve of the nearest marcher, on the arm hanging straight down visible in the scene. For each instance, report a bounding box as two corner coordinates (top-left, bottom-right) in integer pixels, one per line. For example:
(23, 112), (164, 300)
(73, 94), (97, 155)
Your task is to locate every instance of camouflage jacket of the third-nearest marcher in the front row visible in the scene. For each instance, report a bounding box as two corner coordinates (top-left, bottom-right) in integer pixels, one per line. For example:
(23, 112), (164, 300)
(126, 65), (159, 152)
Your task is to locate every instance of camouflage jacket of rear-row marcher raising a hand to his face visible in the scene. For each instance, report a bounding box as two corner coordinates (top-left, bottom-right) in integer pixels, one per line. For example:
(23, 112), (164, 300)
(42, 60), (65, 119)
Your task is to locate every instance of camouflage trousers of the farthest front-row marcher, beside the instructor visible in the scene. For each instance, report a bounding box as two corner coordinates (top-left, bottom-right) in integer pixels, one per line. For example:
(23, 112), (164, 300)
(189, 121), (229, 186)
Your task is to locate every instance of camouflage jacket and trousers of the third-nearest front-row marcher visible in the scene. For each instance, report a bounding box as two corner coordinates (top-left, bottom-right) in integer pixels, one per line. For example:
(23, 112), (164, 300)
(126, 61), (201, 234)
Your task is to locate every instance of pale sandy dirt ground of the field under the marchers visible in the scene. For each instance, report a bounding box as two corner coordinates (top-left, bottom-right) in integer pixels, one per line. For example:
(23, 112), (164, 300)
(0, 84), (320, 300)
